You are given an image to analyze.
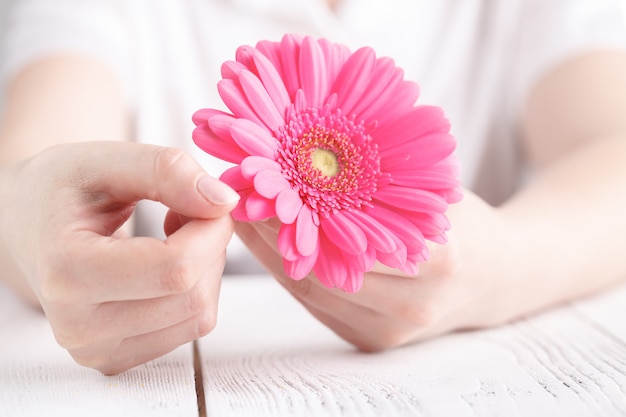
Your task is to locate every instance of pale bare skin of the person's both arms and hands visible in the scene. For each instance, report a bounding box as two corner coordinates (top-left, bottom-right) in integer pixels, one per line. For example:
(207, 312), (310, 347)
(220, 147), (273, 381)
(0, 46), (626, 374)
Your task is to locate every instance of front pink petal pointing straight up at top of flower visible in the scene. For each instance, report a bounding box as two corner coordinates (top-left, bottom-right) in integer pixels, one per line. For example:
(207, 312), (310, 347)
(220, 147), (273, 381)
(299, 36), (328, 107)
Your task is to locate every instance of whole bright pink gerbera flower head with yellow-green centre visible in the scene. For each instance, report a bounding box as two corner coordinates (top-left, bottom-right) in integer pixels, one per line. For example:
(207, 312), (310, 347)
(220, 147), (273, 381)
(193, 35), (461, 292)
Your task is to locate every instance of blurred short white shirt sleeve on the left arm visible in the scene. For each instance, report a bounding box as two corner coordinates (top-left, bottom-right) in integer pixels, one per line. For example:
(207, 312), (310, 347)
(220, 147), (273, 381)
(0, 0), (133, 99)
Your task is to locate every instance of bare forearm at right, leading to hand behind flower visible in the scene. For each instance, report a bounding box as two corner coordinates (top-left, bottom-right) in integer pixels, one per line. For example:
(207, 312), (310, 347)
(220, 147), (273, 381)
(499, 135), (626, 308)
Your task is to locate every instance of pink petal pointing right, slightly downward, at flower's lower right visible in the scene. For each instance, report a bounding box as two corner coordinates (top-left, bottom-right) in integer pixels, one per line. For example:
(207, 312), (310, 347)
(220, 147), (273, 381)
(374, 185), (448, 213)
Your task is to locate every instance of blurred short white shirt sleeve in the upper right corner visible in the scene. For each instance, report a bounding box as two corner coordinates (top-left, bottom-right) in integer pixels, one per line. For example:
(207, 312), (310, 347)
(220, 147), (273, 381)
(513, 0), (626, 112)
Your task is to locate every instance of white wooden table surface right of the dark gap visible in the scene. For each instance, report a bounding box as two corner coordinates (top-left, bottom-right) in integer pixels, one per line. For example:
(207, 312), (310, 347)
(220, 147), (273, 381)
(200, 278), (626, 417)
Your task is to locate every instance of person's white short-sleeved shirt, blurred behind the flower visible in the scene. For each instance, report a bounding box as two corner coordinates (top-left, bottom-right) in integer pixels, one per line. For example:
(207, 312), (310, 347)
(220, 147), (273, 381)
(2, 0), (626, 272)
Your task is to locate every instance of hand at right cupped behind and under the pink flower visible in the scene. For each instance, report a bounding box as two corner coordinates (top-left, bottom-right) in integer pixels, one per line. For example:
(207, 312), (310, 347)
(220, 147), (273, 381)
(235, 191), (530, 351)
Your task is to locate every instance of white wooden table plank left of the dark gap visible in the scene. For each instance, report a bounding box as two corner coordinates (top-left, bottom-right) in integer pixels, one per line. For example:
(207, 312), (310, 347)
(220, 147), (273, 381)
(0, 287), (198, 417)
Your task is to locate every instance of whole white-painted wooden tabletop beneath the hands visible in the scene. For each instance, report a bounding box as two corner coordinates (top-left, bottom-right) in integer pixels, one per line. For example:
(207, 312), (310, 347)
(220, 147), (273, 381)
(0, 276), (626, 417)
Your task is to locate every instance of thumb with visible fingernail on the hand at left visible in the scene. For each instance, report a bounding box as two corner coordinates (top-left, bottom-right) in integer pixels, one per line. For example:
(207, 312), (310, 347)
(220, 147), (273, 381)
(73, 142), (239, 219)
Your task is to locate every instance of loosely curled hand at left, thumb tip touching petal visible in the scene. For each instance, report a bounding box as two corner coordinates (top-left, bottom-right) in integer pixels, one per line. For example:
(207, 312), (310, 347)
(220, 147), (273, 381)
(0, 142), (238, 374)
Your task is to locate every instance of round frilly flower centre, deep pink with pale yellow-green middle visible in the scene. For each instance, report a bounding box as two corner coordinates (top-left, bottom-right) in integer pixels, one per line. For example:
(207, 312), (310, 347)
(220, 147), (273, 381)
(276, 108), (383, 216)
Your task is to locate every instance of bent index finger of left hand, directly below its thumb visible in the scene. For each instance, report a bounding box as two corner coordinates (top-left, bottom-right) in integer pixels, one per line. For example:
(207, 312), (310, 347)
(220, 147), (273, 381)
(50, 216), (233, 304)
